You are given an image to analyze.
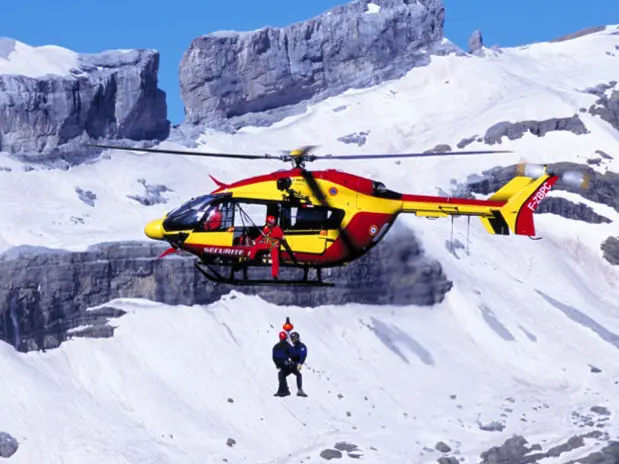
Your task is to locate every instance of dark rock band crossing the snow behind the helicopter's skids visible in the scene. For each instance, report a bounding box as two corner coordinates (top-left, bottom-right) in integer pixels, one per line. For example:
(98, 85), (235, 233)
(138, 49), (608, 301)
(0, 231), (452, 351)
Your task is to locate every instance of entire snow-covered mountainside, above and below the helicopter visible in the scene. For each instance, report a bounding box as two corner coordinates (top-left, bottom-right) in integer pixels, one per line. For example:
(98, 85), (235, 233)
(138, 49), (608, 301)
(0, 21), (619, 464)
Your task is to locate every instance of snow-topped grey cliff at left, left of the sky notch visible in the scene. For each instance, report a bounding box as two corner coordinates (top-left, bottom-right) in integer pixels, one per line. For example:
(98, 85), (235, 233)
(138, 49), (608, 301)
(0, 39), (170, 163)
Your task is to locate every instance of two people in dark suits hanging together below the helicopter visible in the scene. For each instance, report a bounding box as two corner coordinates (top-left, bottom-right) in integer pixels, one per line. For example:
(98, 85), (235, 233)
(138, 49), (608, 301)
(273, 332), (307, 396)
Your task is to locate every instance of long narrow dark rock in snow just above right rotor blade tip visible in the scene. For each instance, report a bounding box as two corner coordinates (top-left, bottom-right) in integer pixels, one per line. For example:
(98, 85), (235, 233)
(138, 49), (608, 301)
(484, 114), (589, 145)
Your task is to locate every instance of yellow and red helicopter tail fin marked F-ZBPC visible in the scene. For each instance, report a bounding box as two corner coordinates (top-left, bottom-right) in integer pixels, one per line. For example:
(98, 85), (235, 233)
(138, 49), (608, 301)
(481, 173), (559, 237)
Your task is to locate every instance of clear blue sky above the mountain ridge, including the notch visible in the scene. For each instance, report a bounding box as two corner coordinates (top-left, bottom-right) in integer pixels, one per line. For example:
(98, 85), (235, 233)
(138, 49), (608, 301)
(0, 0), (619, 124)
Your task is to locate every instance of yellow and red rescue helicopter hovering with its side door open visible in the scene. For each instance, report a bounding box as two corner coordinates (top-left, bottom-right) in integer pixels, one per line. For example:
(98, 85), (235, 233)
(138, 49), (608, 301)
(90, 145), (588, 287)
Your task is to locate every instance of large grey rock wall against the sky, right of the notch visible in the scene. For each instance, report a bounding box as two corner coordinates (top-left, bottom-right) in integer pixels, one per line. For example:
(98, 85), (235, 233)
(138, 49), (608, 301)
(180, 0), (462, 129)
